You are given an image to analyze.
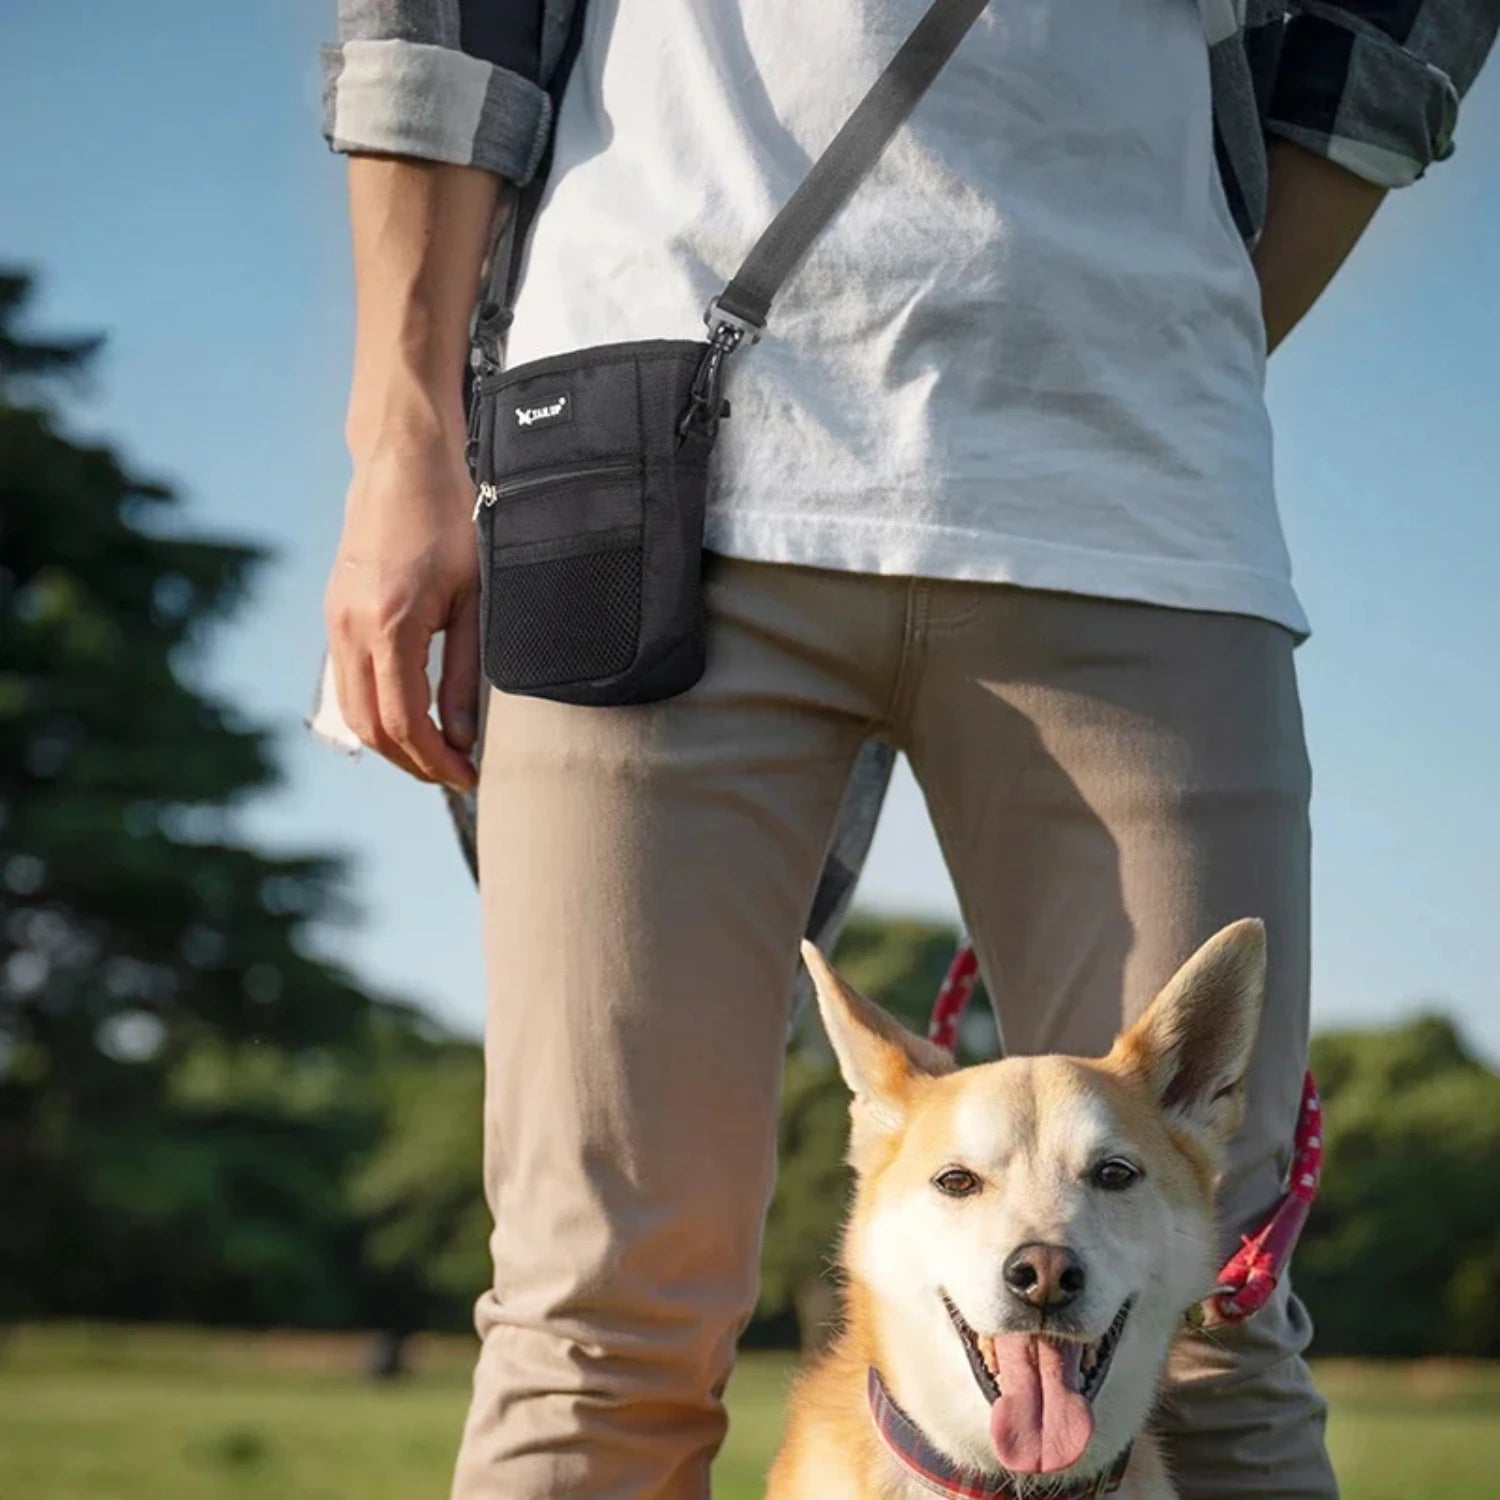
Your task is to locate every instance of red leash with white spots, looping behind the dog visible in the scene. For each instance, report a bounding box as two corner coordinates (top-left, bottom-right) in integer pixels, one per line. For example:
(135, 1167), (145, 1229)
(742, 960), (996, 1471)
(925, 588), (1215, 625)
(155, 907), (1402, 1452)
(927, 944), (1323, 1323)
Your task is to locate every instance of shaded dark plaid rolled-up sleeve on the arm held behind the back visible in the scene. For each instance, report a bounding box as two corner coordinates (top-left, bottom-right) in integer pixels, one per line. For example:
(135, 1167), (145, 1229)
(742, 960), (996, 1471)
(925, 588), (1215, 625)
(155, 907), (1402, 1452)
(1266, 0), (1500, 188)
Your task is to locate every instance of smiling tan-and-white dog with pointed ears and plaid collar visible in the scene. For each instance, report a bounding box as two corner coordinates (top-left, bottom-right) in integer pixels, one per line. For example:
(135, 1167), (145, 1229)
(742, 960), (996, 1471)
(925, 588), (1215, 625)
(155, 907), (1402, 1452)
(767, 920), (1266, 1500)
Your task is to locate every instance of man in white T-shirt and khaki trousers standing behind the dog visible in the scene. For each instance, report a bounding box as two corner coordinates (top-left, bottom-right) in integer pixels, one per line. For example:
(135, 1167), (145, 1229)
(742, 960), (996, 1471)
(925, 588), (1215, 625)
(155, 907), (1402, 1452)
(313, 0), (1497, 1500)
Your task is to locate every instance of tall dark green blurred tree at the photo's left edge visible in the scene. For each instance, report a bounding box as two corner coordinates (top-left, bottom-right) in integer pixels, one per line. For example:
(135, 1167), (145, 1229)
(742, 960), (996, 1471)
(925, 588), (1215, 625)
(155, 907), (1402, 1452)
(0, 273), (393, 1322)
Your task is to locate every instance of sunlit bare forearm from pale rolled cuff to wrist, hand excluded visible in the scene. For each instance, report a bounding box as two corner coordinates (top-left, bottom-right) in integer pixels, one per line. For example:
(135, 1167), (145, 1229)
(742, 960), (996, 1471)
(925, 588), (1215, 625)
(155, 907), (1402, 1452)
(347, 156), (509, 455)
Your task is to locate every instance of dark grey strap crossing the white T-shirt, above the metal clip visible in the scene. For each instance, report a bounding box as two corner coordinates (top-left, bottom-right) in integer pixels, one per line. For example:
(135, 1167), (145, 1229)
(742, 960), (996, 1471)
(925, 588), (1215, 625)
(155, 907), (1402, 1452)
(717, 0), (986, 329)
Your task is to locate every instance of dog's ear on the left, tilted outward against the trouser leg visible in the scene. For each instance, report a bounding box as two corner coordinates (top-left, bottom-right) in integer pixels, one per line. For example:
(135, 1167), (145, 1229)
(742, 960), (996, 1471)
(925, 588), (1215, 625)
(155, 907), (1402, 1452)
(803, 942), (954, 1131)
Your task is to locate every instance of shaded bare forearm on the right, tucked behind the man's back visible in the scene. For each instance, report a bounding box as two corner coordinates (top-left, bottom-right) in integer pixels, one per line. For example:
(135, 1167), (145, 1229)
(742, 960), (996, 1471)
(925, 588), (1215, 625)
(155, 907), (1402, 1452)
(1254, 140), (1385, 350)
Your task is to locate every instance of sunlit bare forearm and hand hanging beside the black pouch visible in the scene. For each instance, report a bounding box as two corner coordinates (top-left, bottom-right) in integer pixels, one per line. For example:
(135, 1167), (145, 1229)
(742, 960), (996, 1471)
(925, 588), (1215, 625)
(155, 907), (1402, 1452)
(324, 156), (498, 791)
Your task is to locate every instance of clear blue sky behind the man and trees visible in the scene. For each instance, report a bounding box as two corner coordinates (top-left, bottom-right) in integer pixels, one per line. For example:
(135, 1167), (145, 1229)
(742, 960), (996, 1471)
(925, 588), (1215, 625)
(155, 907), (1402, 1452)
(0, 0), (1500, 1058)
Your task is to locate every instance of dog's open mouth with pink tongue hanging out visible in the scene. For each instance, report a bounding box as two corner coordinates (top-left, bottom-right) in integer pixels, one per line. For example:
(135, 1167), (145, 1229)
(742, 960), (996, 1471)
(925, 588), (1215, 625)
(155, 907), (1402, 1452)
(942, 1293), (1134, 1475)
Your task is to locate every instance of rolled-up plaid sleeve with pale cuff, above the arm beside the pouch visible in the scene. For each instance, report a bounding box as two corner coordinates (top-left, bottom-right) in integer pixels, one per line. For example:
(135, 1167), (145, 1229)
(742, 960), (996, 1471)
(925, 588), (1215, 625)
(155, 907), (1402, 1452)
(323, 0), (552, 186)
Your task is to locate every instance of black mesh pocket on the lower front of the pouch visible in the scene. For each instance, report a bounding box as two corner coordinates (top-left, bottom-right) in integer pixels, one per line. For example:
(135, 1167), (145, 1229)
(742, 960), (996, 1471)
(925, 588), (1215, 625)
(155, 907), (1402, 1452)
(485, 543), (641, 690)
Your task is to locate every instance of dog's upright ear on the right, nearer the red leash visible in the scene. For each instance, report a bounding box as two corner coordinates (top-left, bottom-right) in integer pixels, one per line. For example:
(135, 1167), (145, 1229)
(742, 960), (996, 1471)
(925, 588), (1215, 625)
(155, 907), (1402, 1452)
(1112, 920), (1266, 1142)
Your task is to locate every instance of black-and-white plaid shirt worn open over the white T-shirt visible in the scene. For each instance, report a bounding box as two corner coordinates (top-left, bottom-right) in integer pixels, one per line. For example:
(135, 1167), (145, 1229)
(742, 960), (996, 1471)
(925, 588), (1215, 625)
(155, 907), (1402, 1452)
(311, 0), (1500, 972)
